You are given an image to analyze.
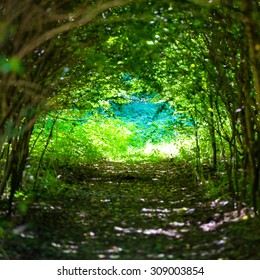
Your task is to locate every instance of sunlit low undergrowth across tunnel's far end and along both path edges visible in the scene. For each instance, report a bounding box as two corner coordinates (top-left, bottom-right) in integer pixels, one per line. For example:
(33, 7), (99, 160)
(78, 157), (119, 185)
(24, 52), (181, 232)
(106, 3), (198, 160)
(1, 106), (242, 213)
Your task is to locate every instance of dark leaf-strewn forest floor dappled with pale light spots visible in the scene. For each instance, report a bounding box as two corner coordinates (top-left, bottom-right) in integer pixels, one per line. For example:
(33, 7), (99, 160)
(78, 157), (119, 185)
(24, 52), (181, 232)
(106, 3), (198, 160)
(0, 161), (260, 260)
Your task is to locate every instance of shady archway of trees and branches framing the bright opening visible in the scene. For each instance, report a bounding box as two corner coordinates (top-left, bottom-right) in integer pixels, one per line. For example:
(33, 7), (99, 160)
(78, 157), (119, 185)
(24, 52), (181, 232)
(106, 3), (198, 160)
(0, 0), (260, 214)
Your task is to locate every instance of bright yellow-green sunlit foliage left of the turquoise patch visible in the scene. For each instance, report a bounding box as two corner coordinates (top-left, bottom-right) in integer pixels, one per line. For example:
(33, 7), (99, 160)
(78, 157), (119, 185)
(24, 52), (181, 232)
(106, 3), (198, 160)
(32, 112), (157, 164)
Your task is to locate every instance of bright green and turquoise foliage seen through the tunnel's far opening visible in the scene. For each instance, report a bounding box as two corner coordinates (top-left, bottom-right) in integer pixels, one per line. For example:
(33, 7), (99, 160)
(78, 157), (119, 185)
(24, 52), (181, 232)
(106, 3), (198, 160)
(31, 92), (195, 165)
